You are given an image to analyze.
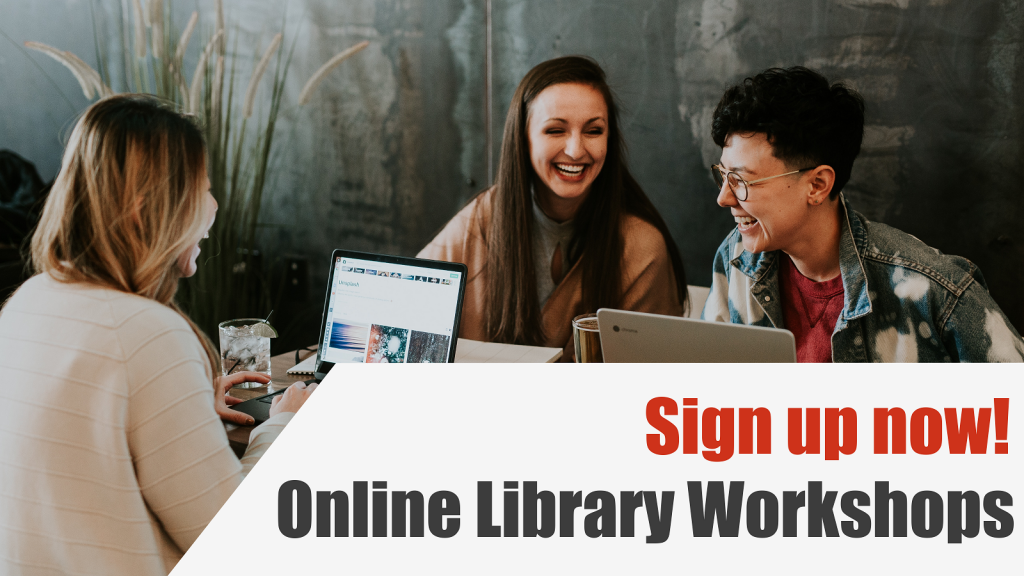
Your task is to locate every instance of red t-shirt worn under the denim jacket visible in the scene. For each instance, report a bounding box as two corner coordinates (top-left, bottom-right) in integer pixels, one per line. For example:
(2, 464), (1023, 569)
(778, 253), (843, 362)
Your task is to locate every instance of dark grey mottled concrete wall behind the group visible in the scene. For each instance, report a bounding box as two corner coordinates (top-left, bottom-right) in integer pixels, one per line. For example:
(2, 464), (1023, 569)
(0, 0), (1024, 340)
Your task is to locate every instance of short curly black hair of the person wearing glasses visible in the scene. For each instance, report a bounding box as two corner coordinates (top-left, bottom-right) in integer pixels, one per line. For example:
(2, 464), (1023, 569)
(711, 66), (864, 198)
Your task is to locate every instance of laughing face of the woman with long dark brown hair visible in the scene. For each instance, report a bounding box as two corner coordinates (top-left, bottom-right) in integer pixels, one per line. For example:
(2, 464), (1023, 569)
(526, 84), (608, 219)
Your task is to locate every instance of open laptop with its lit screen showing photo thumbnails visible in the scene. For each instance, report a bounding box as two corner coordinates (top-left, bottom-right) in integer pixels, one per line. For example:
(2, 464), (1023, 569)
(233, 250), (466, 423)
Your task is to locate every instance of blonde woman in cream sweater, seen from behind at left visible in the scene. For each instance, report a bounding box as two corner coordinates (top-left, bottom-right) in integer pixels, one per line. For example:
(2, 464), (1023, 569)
(0, 95), (313, 575)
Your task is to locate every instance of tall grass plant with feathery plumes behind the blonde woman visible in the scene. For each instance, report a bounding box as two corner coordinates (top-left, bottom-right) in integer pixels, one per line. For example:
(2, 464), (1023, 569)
(26, 0), (369, 338)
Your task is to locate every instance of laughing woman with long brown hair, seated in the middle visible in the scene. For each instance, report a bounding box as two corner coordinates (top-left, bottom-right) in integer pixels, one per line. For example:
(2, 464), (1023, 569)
(419, 56), (686, 360)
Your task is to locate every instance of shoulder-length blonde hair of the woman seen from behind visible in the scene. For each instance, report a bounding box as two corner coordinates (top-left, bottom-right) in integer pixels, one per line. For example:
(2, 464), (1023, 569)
(31, 94), (218, 377)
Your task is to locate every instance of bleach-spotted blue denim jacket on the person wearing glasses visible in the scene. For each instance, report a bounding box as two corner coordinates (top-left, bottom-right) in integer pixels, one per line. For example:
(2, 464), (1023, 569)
(701, 194), (1024, 362)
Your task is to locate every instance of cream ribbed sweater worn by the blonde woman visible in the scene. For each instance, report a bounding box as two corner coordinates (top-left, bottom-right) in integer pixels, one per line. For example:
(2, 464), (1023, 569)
(0, 275), (292, 576)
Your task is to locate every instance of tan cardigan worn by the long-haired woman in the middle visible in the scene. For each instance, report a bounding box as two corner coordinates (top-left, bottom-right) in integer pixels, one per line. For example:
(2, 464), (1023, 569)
(418, 189), (683, 362)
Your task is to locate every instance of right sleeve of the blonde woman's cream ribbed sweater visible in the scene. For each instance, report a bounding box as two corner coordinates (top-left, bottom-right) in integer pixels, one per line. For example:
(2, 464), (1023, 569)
(122, 310), (289, 551)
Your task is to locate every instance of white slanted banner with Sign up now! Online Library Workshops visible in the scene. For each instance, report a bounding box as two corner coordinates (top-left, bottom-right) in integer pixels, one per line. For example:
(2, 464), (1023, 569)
(174, 365), (1024, 576)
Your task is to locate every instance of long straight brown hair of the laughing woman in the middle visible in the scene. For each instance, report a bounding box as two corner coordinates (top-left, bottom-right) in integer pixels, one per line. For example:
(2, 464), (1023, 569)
(486, 56), (687, 344)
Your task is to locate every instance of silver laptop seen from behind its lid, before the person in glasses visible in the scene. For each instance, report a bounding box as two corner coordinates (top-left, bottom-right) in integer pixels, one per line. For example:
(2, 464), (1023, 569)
(597, 308), (797, 362)
